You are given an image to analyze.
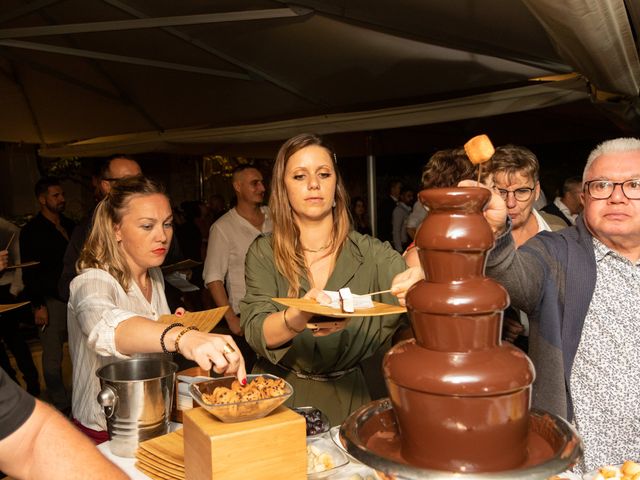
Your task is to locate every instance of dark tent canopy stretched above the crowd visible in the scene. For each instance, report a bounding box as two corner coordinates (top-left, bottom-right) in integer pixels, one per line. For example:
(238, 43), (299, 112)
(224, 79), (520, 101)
(0, 0), (640, 156)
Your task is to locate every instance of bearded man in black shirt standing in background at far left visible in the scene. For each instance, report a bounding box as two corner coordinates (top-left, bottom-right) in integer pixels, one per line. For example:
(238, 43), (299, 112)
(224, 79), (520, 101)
(20, 177), (75, 413)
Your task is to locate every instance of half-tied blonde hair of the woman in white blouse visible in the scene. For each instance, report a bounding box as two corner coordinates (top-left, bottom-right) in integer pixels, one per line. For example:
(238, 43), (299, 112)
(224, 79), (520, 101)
(76, 176), (165, 291)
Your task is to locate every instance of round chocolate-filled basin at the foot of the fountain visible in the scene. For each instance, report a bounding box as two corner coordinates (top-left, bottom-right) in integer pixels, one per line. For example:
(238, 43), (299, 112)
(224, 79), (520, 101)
(340, 398), (582, 480)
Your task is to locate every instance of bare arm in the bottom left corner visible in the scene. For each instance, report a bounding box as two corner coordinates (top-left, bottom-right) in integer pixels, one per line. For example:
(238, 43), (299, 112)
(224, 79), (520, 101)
(0, 400), (129, 480)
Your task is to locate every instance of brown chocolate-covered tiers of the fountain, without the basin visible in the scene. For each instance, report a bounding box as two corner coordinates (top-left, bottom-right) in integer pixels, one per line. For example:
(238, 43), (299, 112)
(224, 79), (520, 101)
(384, 187), (535, 472)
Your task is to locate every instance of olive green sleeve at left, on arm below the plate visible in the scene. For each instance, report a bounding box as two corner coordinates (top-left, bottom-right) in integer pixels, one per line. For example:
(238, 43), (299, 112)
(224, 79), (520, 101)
(240, 236), (291, 364)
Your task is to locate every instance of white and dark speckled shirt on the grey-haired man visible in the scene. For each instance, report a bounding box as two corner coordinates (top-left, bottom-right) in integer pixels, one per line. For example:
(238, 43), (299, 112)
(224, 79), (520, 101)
(570, 238), (640, 471)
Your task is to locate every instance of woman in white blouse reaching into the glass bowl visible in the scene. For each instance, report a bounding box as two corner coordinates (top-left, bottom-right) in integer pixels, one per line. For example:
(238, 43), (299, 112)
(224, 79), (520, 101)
(67, 177), (246, 443)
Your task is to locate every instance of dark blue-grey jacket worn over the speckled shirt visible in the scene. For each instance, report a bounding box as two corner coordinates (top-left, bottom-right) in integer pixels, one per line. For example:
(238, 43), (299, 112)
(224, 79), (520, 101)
(487, 216), (596, 420)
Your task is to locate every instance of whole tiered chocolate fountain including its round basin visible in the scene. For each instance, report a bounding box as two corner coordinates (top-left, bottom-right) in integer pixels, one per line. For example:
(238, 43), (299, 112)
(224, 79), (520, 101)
(340, 187), (581, 479)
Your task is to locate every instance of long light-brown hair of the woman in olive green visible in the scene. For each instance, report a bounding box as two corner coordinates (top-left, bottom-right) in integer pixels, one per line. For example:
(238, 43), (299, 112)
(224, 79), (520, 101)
(269, 133), (351, 297)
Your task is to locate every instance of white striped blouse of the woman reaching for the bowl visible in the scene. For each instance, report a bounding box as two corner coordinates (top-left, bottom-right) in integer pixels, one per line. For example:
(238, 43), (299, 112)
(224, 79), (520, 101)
(67, 268), (171, 430)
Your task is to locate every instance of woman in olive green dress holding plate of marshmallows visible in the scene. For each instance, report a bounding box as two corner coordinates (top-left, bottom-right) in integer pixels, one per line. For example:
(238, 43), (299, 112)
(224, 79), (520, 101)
(240, 134), (406, 425)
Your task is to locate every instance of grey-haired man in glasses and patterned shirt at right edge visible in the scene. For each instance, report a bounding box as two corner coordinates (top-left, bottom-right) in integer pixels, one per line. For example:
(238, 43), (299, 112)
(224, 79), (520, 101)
(485, 138), (640, 470)
